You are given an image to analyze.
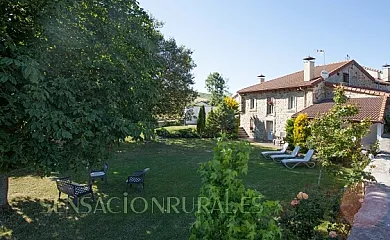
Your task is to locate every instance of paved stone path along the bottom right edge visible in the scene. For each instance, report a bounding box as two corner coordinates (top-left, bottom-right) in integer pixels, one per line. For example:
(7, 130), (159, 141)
(348, 154), (390, 240)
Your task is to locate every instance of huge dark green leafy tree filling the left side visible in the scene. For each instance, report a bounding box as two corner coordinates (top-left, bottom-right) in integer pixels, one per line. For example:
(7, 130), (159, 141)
(0, 0), (192, 205)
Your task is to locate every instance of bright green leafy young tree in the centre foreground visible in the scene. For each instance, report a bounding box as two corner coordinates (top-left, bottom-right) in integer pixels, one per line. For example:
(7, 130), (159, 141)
(190, 138), (282, 239)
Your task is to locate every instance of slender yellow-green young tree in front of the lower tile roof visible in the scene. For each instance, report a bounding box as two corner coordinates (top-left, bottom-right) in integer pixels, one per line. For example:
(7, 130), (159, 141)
(309, 87), (371, 186)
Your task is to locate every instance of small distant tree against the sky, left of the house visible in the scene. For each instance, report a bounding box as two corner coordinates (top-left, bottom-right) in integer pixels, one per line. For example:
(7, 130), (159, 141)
(206, 72), (227, 106)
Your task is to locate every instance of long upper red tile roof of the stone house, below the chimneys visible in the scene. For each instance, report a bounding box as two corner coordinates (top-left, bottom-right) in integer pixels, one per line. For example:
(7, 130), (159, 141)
(238, 60), (352, 93)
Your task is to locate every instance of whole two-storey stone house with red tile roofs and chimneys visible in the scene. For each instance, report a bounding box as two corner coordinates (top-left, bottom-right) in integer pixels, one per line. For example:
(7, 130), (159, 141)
(237, 57), (390, 148)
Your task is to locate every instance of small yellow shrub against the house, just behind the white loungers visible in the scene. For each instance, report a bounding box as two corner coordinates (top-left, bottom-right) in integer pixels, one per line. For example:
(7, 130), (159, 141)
(293, 114), (310, 151)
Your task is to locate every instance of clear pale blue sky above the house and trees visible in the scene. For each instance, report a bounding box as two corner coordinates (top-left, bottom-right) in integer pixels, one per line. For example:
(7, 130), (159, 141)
(139, 0), (390, 93)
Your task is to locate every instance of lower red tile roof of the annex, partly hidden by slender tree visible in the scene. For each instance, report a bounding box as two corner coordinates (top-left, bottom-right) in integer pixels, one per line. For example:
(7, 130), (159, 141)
(292, 96), (387, 123)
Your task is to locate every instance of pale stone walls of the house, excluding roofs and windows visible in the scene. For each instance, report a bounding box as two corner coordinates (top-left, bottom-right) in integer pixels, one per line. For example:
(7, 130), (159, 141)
(240, 61), (390, 141)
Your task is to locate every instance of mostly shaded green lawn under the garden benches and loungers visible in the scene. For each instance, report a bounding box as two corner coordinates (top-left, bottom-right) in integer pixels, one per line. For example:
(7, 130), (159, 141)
(0, 139), (340, 239)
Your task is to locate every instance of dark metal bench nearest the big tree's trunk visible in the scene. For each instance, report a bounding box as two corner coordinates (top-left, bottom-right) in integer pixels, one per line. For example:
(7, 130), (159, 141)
(56, 177), (95, 205)
